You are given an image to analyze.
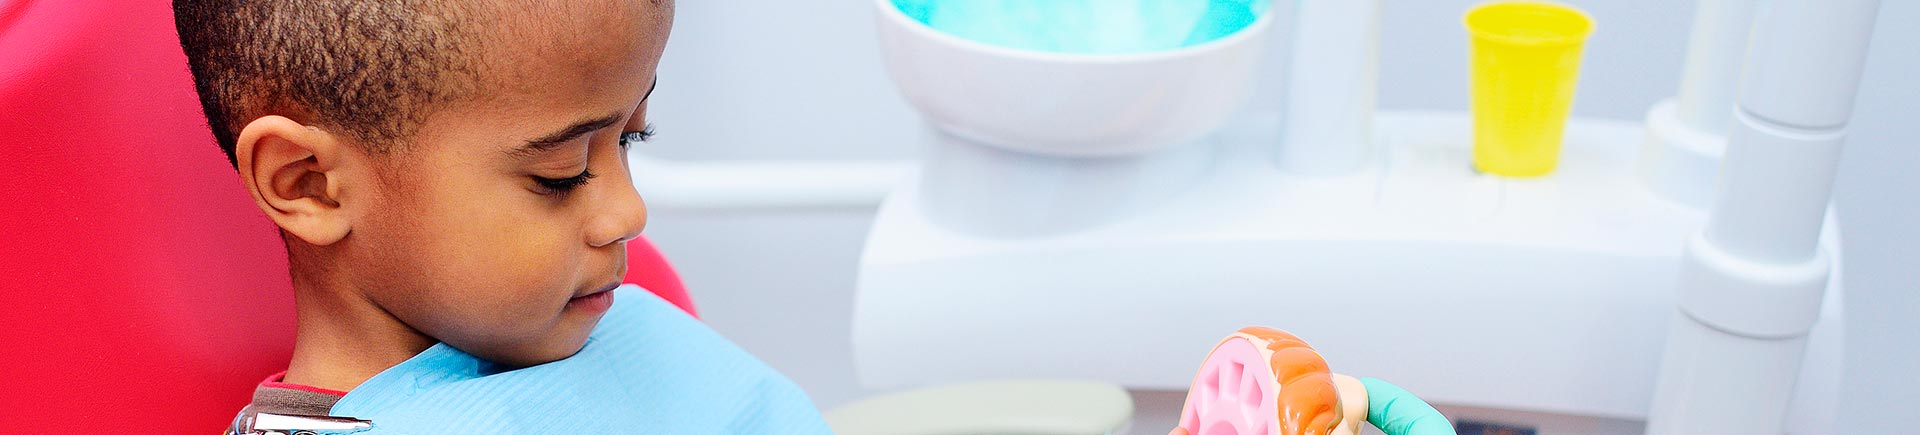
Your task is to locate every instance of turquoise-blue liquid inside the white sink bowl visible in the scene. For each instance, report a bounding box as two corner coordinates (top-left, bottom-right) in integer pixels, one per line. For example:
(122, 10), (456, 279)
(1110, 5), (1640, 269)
(893, 0), (1267, 54)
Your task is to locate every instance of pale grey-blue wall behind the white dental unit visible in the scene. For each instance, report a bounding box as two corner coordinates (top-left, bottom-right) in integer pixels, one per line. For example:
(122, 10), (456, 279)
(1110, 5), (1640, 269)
(641, 0), (1920, 433)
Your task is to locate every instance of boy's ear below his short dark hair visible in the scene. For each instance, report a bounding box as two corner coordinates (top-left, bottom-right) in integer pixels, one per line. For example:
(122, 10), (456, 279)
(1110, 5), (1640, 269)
(234, 115), (353, 245)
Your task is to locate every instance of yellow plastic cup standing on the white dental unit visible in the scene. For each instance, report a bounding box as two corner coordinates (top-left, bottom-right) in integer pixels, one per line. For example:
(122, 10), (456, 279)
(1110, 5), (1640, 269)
(1465, 2), (1594, 176)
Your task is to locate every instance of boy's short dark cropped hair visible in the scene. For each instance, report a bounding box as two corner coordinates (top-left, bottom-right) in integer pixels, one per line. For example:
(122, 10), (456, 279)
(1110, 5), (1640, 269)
(173, 0), (478, 167)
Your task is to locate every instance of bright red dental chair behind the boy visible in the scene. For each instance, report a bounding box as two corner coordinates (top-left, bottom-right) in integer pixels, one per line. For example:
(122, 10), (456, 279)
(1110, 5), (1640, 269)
(0, 0), (693, 433)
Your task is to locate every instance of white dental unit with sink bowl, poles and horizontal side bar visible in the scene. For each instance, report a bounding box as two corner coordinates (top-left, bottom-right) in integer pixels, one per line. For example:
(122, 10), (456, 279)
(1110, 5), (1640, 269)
(634, 0), (1878, 435)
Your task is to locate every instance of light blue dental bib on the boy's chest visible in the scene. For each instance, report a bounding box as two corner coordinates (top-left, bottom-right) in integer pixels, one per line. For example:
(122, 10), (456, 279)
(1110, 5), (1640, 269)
(332, 286), (831, 435)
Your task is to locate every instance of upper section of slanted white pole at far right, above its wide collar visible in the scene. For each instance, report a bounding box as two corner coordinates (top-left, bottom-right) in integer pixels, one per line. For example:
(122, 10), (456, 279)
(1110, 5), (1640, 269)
(1707, 0), (1880, 264)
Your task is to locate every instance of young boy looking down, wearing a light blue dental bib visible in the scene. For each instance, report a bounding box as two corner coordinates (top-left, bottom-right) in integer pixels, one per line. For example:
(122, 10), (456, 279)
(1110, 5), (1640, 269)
(175, 0), (824, 433)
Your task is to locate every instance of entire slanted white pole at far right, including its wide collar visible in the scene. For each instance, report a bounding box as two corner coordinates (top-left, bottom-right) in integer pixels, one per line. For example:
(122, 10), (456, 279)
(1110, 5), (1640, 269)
(1647, 0), (1880, 435)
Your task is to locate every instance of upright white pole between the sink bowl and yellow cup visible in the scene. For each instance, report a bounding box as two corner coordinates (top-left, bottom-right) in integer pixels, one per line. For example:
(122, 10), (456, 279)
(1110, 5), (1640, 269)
(1275, 0), (1380, 174)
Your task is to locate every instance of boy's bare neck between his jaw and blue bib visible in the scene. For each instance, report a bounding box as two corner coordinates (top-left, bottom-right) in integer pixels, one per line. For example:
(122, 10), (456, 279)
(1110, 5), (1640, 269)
(284, 278), (438, 391)
